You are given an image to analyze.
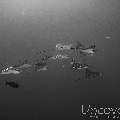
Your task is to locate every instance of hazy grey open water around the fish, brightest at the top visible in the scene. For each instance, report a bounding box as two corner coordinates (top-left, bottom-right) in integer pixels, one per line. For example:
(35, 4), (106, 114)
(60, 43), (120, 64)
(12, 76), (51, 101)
(0, 0), (120, 120)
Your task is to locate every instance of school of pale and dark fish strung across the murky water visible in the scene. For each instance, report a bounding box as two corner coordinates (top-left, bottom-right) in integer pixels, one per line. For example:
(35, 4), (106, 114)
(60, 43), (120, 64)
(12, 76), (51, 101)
(0, 41), (103, 88)
